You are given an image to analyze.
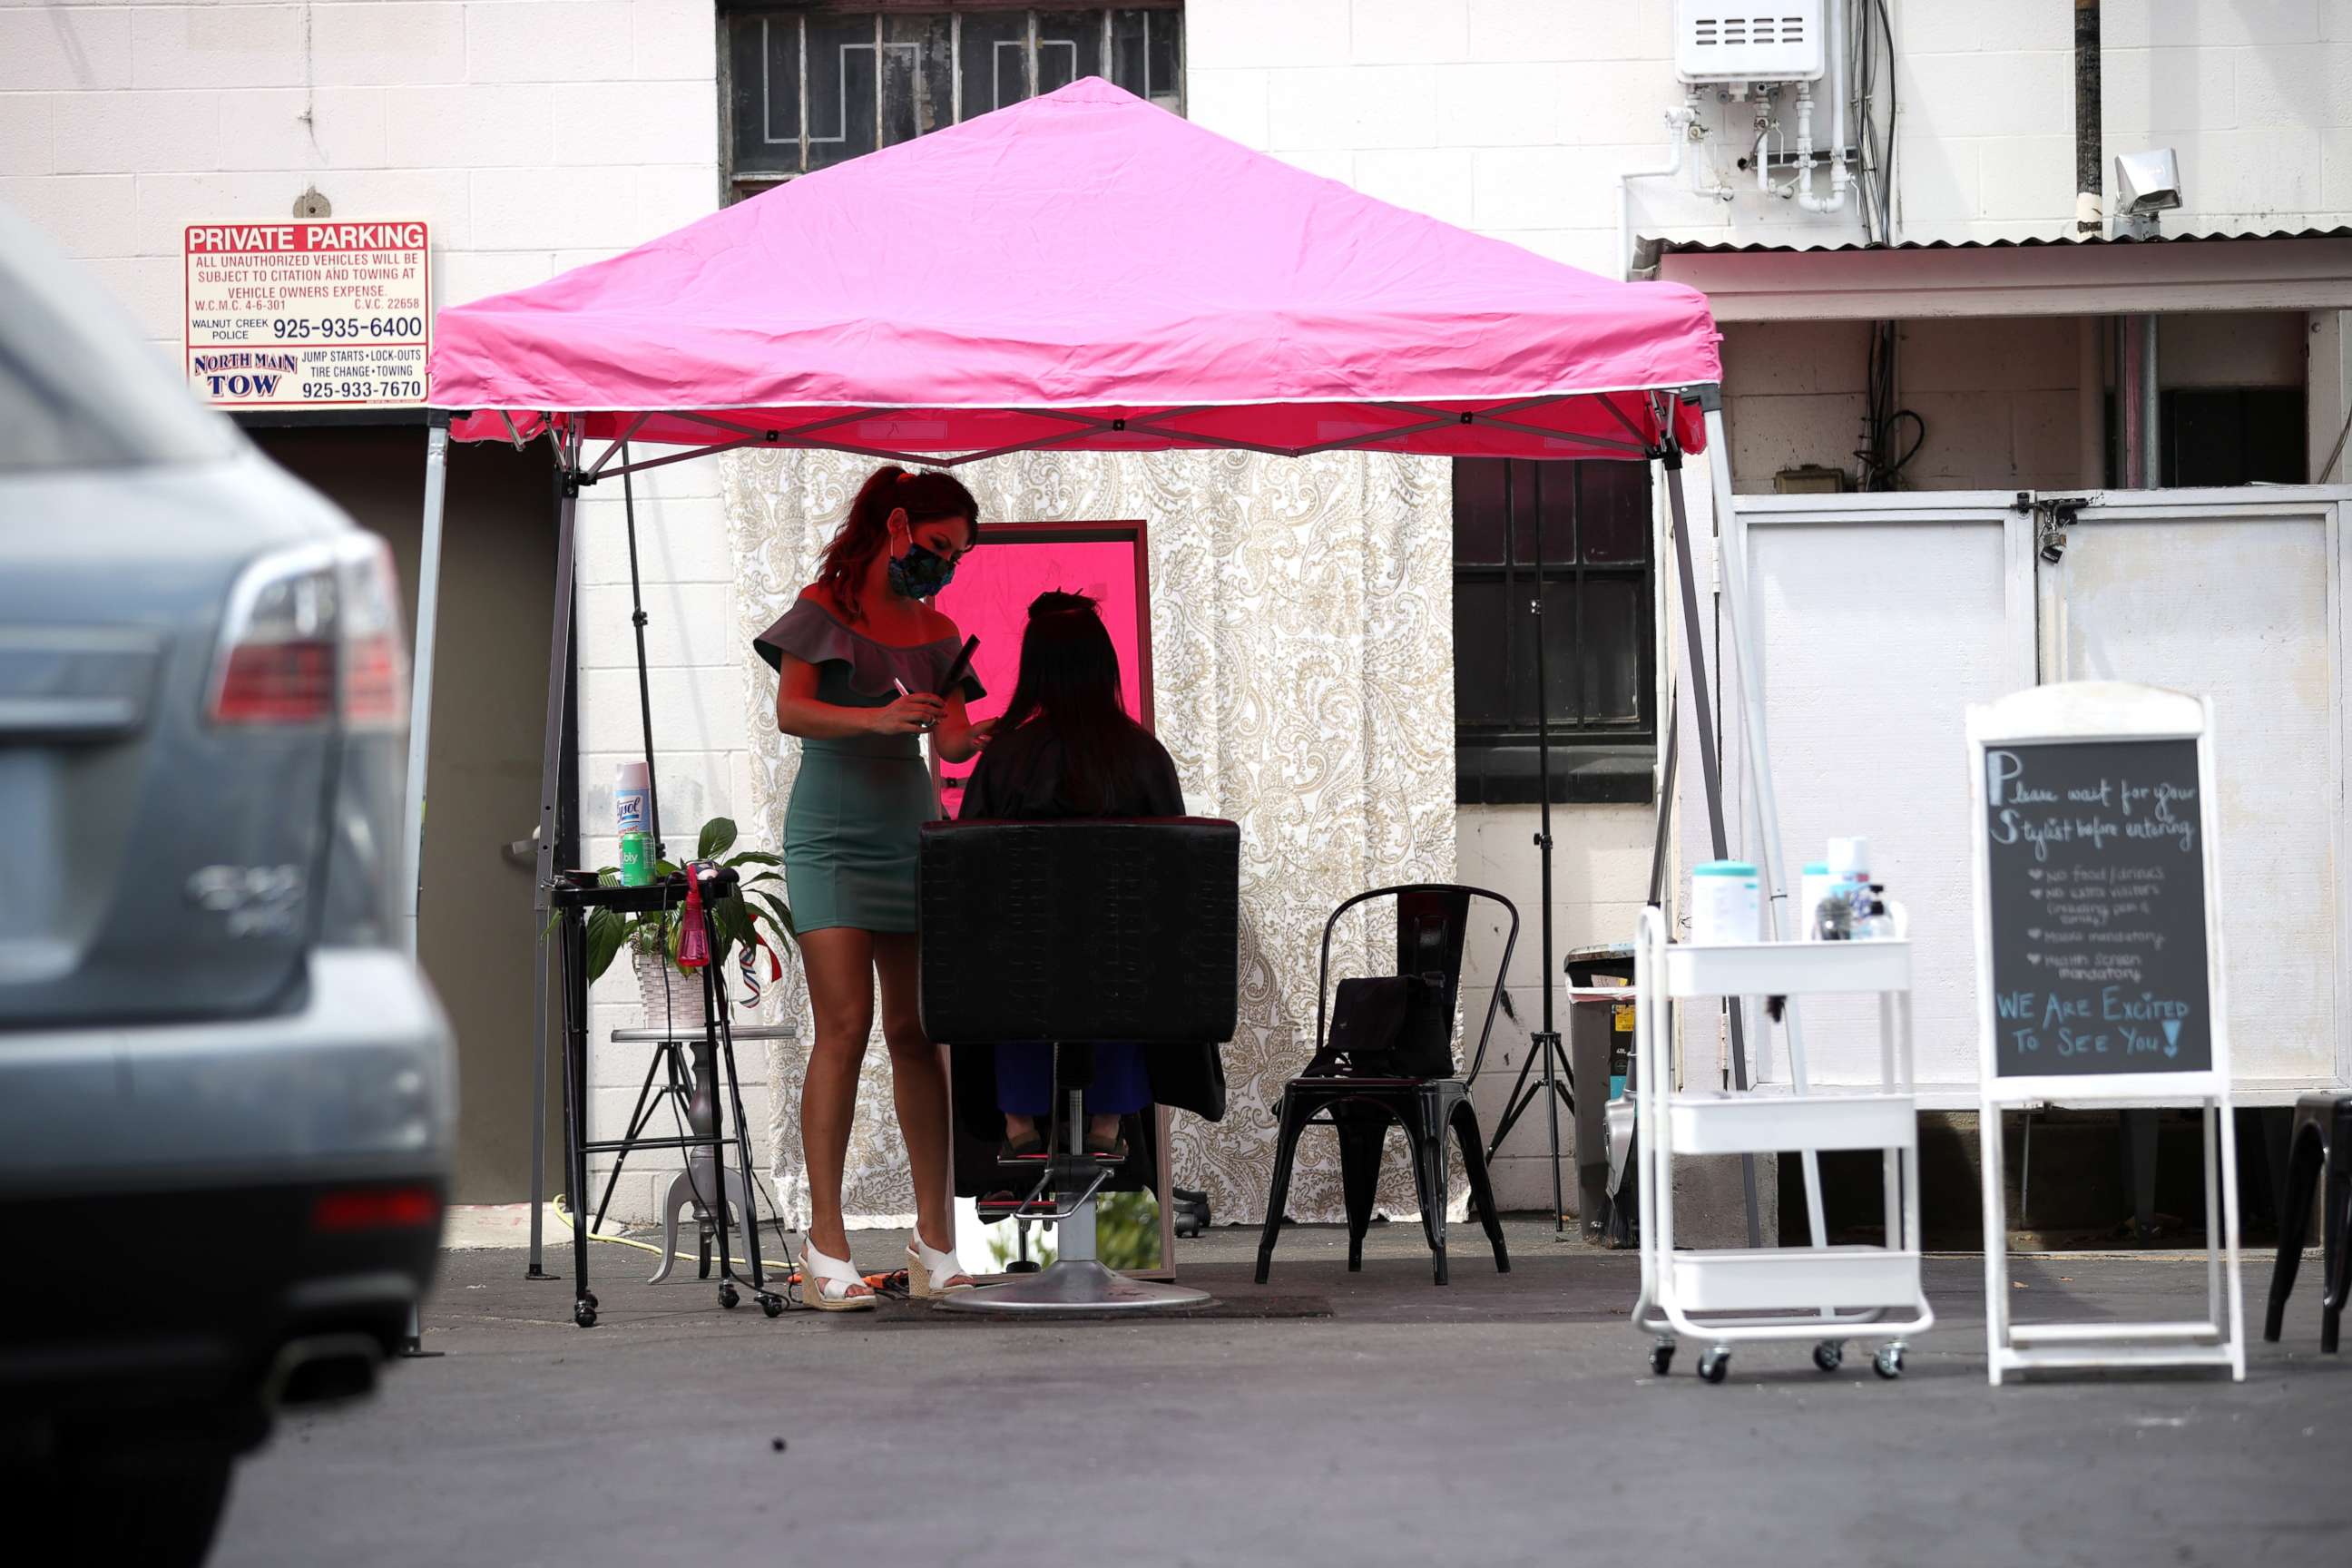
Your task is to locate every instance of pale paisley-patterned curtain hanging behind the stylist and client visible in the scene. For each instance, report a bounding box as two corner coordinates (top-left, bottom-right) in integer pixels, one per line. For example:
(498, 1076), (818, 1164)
(722, 451), (1458, 1225)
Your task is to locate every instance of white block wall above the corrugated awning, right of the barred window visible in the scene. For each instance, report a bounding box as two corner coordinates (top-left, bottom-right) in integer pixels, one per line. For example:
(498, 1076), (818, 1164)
(1185, 0), (2352, 275)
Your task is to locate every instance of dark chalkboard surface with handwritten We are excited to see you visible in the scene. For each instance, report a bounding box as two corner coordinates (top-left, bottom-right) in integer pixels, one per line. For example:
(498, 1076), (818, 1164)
(1980, 738), (2213, 1077)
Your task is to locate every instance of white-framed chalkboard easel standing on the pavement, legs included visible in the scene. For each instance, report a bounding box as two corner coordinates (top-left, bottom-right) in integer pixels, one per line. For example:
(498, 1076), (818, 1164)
(1969, 681), (2246, 1385)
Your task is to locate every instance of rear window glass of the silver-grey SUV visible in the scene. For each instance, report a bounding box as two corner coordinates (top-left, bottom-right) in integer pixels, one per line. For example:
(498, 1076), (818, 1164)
(0, 207), (238, 473)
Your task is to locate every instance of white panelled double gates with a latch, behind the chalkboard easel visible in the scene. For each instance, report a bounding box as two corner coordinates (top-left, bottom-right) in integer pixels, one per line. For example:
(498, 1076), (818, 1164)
(1721, 489), (2352, 1105)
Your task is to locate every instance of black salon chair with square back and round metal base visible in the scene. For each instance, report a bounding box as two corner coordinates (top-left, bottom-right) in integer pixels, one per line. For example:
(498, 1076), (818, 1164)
(919, 818), (1242, 1312)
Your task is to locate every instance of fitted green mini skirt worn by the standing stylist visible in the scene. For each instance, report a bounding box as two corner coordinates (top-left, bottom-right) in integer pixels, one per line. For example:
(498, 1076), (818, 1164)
(783, 736), (938, 931)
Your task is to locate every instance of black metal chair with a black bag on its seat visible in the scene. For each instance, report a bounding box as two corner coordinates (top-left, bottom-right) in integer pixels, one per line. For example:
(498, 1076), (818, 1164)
(1259, 882), (1519, 1286)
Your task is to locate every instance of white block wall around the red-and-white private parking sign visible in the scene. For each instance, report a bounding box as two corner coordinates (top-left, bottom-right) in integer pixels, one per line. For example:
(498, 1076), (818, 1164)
(0, 0), (733, 1215)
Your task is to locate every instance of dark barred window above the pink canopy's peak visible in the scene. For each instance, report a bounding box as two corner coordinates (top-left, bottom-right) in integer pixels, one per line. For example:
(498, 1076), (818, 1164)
(720, 0), (1183, 198)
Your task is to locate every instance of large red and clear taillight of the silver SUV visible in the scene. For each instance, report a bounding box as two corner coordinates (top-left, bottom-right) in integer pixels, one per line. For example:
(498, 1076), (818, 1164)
(207, 534), (409, 729)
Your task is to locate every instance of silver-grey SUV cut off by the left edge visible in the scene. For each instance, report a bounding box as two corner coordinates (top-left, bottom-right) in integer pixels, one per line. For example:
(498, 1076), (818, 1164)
(0, 207), (454, 1563)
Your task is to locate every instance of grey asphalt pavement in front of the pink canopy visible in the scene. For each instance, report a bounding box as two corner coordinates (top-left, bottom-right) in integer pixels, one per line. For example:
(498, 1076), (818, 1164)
(214, 1220), (2352, 1568)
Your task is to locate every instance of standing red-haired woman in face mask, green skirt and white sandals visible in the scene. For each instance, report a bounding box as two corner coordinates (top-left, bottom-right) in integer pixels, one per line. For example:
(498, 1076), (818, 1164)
(758, 468), (988, 1312)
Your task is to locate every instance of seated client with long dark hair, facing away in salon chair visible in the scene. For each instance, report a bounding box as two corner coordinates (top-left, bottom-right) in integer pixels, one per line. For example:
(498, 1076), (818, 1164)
(955, 593), (1225, 1159)
